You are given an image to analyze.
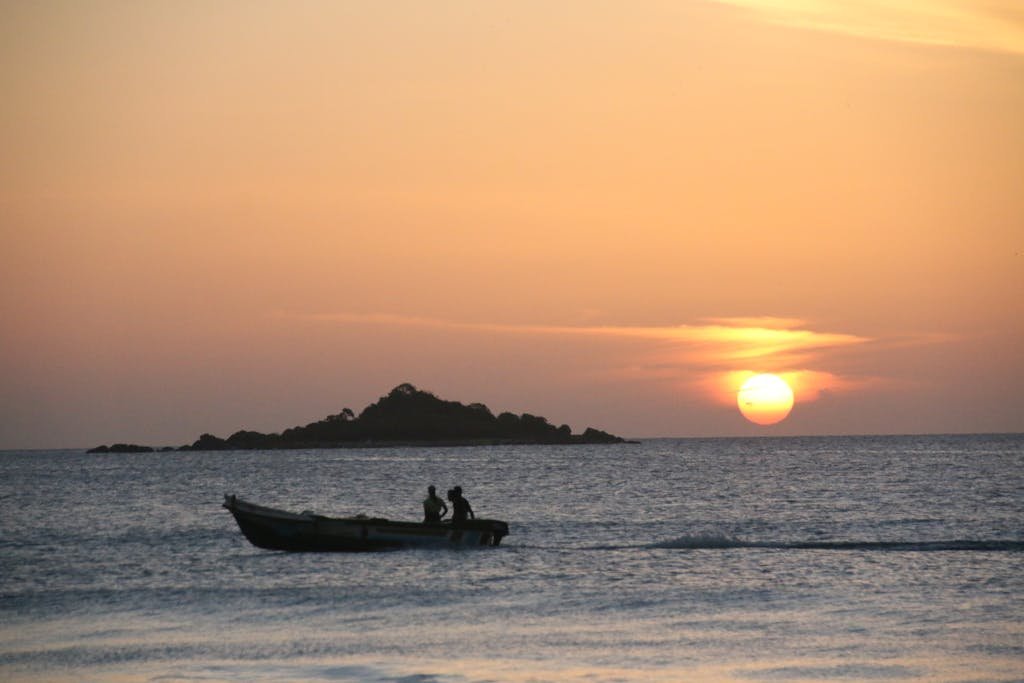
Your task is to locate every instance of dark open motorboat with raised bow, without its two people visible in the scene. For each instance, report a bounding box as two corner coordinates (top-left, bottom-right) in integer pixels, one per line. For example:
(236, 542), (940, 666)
(224, 495), (509, 552)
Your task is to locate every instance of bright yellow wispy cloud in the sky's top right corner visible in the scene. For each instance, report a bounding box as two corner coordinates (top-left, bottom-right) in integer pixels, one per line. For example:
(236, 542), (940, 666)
(719, 0), (1024, 55)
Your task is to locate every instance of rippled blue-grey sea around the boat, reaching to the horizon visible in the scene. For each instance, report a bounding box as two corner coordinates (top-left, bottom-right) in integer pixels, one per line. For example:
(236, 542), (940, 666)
(0, 435), (1024, 683)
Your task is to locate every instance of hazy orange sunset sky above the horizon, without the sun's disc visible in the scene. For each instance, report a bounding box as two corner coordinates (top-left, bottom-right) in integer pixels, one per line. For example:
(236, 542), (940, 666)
(0, 0), (1024, 449)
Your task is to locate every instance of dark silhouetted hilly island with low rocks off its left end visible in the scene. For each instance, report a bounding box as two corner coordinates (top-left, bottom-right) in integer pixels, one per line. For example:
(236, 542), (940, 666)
(90, 383), (628, 453)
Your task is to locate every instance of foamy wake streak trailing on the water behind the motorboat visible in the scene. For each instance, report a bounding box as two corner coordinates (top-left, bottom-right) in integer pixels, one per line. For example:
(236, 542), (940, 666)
(647, 536), (1024, 553)
